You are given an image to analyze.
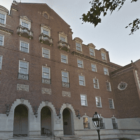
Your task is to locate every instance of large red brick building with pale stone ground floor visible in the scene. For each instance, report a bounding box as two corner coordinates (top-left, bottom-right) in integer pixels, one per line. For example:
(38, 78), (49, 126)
(0, 1), (140, 139)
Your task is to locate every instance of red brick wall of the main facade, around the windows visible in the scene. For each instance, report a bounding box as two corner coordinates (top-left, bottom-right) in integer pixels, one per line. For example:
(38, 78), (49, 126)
(0, 4), (125, 117)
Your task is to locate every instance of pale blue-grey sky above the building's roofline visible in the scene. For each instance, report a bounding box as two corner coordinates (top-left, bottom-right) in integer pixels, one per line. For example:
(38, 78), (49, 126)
(0, 0), (140, 66)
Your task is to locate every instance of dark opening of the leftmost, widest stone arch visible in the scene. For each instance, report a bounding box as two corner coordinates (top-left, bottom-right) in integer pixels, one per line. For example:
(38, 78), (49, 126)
(14, 105), (28, 137)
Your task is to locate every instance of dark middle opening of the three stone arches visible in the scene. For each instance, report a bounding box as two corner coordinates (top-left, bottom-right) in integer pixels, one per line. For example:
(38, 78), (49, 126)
(41, 107), (52, 135)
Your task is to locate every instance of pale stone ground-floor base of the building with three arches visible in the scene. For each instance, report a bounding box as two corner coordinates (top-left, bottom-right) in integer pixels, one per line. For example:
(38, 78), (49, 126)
(0, 99), (140, 140)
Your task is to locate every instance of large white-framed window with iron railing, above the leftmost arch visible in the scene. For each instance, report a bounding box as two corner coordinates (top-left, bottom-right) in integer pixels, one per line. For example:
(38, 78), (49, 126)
(19, 60), (28, 74)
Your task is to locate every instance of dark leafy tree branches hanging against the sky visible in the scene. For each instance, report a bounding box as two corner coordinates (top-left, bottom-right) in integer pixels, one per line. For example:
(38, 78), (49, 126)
(81, 0), (140, 35)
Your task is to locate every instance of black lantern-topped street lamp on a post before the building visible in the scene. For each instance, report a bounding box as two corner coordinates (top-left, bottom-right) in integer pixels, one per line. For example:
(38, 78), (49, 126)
(92, 112), (101, 140)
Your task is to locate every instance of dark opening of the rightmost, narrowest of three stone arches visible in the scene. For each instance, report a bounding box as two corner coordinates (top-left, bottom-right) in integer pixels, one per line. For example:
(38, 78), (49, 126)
(63, 108), (72, 135)
